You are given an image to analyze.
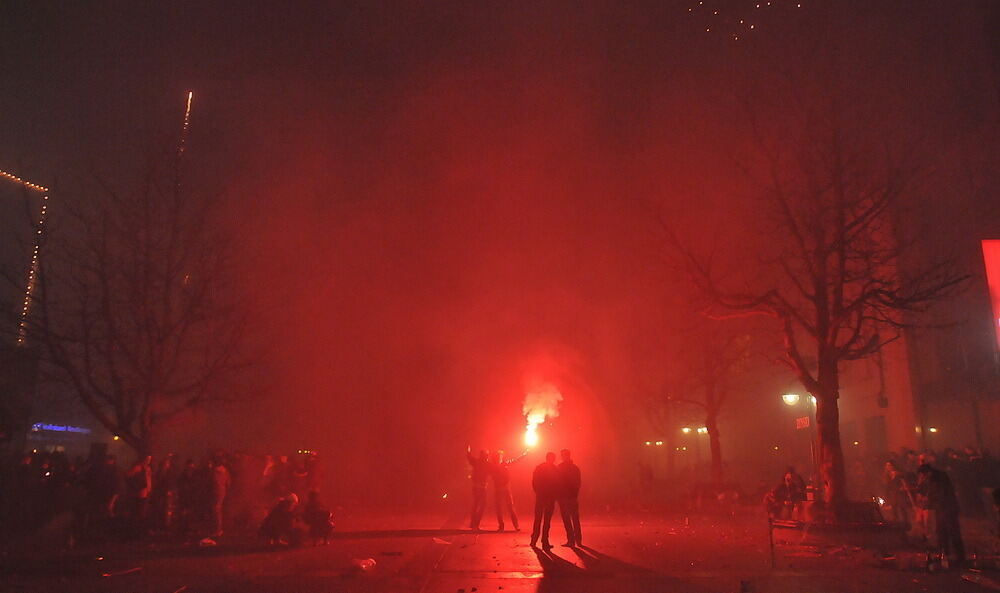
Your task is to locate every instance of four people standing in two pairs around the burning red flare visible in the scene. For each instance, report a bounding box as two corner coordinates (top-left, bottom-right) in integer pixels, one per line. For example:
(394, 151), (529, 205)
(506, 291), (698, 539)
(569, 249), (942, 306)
(468, 448), (583, 549)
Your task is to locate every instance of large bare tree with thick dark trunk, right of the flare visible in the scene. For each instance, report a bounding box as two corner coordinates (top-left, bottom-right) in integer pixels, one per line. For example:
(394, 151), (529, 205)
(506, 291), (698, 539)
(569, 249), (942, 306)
(665, 106), (965, 516)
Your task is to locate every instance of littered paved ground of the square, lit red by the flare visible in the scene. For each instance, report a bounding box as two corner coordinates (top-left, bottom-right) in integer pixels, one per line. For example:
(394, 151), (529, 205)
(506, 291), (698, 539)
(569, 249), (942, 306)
(0, 508), (1000, 593)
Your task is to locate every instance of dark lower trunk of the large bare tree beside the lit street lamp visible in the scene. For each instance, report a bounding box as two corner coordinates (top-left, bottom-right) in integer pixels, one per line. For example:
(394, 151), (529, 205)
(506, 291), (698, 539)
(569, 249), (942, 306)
(813, 387), (847, 520)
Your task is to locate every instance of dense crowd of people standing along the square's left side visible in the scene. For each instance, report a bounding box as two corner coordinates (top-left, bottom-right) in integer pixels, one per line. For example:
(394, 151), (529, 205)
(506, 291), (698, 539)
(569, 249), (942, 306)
(0, 451), (332, 543)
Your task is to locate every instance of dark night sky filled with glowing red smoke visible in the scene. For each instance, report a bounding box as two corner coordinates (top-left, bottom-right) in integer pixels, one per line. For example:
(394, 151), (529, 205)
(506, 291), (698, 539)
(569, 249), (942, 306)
(0, 0), (1000, 504)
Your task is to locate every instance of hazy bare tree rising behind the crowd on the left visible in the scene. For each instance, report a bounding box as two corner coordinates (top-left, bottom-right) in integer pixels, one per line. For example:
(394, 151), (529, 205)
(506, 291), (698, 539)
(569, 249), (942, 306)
(29, 153), (243, 453)
